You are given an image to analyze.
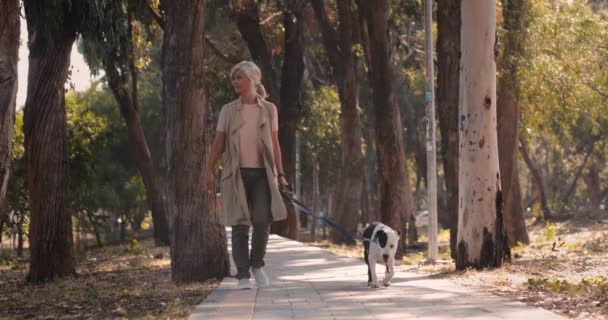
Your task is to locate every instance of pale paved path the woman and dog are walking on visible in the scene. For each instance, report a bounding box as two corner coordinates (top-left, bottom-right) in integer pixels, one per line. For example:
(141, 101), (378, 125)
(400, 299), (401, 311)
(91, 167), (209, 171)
(188, 228), (566, 320)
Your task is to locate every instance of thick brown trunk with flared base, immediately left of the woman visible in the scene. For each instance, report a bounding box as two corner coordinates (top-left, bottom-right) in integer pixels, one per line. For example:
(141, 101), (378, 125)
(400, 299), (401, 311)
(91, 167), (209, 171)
(162, 0), (230, 283)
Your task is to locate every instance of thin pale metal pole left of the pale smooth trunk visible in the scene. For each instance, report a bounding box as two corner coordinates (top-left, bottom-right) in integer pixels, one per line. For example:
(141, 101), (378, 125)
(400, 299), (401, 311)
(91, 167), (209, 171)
(424, 0), (438, 261)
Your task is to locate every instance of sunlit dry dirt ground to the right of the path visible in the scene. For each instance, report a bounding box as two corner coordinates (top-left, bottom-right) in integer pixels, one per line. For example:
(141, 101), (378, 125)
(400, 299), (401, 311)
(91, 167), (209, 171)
(313, 215), (608, 319)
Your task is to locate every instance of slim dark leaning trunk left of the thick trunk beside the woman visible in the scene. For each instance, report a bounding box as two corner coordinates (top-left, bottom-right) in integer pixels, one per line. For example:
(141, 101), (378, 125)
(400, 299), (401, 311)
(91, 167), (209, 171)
(105, 65), (171, 245)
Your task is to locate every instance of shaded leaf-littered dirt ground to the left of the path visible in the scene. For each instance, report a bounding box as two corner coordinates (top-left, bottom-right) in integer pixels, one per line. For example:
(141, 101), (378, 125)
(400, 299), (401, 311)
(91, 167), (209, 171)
(0, 240), (217, 319)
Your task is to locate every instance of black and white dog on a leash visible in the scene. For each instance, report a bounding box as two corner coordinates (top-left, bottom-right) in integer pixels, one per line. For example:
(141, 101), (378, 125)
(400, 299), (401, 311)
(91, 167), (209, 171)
(363, 222), (401, 288)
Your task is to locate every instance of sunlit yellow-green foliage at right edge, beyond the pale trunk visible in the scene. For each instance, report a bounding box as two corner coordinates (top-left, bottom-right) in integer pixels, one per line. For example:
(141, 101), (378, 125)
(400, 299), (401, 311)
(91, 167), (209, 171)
(518, 0), (608, 211)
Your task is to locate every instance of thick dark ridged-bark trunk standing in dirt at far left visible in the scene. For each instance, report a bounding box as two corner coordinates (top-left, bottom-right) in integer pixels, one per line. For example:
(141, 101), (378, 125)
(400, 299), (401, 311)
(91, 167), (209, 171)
(23, 24), (76, 283)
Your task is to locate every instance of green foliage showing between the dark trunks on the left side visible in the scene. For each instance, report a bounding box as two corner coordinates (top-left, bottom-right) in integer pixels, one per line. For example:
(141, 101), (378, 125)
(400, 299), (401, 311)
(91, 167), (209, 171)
(8, 75), (160, 240)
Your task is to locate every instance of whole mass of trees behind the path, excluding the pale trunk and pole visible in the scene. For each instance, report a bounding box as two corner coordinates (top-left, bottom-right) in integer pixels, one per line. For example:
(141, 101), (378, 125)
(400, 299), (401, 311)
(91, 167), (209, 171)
(0, 0), (608, 282)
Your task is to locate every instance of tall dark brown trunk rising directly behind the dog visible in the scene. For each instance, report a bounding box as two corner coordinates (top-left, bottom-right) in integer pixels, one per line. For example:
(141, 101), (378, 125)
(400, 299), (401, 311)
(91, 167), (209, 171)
(359, 0), (415, 259)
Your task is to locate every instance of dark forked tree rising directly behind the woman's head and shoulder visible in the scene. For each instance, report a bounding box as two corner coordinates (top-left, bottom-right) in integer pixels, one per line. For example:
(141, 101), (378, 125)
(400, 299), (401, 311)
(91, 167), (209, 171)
(235, 0), (306, 239)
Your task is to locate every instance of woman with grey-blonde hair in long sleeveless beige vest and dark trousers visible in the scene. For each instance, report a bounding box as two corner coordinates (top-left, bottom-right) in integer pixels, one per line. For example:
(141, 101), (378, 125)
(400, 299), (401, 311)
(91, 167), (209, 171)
(205, 61), (287, 289)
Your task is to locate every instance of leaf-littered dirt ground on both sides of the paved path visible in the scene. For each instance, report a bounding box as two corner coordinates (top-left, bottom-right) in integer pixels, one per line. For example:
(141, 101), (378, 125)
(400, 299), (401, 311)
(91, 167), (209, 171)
(0, 215), (608, 319)
